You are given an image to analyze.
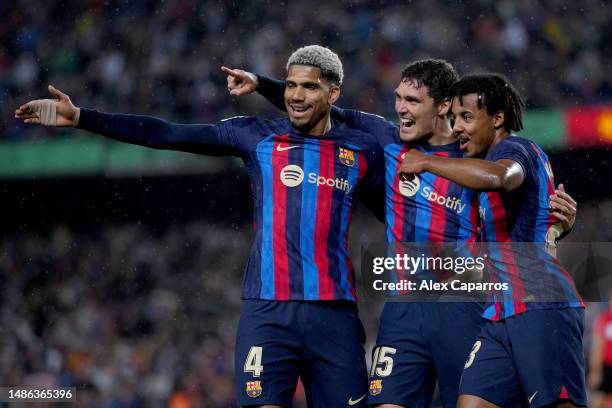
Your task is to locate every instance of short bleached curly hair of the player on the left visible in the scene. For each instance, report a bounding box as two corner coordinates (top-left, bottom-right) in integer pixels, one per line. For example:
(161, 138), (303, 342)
(287, 45), (344, 86)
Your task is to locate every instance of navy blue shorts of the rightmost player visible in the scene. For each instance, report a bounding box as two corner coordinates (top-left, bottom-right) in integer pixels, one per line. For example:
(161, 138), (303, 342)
(459, 308), (586, 408)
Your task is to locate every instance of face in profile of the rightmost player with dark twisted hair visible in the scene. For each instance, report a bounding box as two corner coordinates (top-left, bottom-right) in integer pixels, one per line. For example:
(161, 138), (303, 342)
(451, 93), (504, 157)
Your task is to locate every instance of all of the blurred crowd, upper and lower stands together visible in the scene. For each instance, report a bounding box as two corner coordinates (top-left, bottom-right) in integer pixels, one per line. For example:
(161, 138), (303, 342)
(0, 0), (612, 408)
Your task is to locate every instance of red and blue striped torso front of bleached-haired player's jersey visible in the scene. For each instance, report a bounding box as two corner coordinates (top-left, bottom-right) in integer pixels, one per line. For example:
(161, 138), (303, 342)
(249, 134), (368, 301)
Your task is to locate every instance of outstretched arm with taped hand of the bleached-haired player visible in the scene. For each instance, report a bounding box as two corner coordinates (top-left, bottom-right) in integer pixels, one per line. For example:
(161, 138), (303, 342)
(15, 85), (237, 155)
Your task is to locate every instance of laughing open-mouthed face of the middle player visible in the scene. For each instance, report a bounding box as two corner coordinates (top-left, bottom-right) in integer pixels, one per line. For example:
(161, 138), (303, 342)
(395, 78), (439, 142)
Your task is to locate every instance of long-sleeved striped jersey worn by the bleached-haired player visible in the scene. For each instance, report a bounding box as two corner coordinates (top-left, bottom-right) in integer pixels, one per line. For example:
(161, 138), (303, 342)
(79, 109), (383, 301)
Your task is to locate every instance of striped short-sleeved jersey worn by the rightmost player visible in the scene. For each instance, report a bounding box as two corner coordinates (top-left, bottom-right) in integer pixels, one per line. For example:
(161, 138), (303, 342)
(479, 135), (584, 320)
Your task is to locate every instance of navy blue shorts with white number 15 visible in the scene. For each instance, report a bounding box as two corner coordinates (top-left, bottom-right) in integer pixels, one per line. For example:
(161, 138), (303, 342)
(368, 302), (486, 408)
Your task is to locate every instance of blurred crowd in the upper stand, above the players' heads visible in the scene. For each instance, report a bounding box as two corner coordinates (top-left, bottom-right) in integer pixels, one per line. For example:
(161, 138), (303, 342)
(0, 0), (612, 138)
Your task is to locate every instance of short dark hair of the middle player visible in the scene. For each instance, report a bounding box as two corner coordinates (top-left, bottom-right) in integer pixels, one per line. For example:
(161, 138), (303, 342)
(402, 58), (459, 105)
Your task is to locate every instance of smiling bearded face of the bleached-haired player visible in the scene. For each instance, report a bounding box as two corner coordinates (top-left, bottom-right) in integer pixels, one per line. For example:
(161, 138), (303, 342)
(285, 65), (340, 135)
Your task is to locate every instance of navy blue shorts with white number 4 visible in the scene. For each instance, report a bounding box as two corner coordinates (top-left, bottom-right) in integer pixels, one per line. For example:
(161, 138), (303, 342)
(235, 300), (368, 408)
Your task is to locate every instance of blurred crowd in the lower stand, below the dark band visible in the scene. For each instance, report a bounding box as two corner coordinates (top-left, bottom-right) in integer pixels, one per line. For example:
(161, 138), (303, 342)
(0, 206), (612, 408)
